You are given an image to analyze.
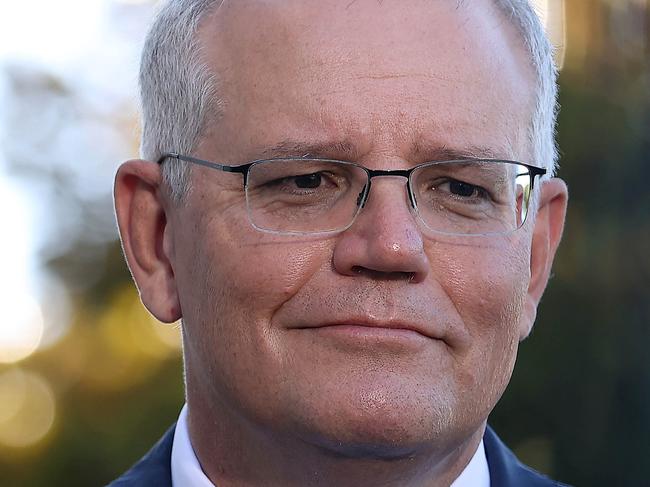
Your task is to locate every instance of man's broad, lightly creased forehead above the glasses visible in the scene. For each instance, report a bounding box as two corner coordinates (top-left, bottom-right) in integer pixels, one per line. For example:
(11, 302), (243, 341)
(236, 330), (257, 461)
(201, 0), (534, 162)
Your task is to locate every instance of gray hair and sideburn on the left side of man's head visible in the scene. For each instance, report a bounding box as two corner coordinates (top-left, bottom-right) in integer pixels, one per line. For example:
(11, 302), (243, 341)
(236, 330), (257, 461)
(140, 0), (222, 201)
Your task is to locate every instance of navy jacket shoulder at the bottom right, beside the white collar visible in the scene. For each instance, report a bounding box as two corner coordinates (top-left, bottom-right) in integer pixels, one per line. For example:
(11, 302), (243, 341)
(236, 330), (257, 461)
(483, 426), (570, 487)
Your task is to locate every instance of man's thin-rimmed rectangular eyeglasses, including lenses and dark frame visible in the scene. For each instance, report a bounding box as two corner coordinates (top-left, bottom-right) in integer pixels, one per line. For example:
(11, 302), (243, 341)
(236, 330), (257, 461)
(158, 153), (546, 235)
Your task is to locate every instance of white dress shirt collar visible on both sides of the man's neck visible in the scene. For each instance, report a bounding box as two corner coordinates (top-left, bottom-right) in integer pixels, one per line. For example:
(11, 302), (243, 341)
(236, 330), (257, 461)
(172, 404), (490, 487)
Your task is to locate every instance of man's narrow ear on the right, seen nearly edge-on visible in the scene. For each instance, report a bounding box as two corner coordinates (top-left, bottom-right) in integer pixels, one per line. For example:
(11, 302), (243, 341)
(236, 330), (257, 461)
(519, 178), (569, 340)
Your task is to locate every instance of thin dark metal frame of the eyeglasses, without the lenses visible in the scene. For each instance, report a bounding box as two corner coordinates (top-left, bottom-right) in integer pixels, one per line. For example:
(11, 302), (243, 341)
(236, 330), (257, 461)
(157, 152), (547, 237)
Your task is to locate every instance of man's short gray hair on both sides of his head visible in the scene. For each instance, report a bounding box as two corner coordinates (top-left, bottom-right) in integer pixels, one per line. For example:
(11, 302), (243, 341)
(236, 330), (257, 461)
(140, 0), (557, 201)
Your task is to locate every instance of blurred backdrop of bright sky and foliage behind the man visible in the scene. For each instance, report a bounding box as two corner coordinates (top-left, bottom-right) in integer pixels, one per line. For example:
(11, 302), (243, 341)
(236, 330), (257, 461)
(0, 0), (650, 487)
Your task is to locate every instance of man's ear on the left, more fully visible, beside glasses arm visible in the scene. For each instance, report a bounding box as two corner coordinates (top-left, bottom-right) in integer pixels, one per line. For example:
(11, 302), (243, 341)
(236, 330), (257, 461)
(114, 160), (181, 323)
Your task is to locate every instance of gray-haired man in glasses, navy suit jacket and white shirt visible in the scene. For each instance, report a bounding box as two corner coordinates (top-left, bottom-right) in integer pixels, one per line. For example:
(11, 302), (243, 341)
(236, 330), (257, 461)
(114, 0), (567, 487)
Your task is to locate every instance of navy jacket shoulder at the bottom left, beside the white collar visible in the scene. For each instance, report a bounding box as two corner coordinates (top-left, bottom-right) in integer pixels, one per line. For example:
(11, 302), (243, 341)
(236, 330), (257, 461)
(108, 424), (176, 487)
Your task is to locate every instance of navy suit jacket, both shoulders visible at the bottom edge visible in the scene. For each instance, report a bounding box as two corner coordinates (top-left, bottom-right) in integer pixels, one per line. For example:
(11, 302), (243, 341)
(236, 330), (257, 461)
(109, 426), (566, 487)
